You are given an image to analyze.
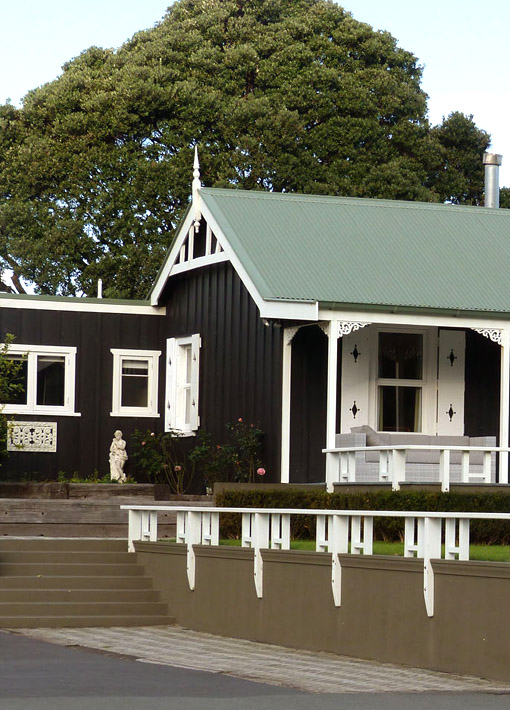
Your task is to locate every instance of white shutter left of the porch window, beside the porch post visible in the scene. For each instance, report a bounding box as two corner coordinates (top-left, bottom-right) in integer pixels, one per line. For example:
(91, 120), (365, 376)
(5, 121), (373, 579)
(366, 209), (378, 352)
(340, 328), (370, 434)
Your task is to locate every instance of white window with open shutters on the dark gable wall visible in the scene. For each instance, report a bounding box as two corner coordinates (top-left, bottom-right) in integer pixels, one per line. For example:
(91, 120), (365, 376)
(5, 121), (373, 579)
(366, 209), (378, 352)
(165, 333), (201, 435)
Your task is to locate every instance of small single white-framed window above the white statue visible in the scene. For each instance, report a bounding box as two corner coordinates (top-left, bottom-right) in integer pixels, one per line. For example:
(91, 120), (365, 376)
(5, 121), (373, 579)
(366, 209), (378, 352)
(110, 349), (161, 417)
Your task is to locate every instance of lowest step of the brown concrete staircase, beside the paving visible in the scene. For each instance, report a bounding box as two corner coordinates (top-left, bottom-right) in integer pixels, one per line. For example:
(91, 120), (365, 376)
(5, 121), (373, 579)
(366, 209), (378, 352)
(0, 614), (175, 629)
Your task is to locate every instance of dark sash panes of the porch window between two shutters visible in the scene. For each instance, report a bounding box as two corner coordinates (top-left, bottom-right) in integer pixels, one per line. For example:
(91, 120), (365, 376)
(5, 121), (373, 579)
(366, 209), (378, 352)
(377, 332), (424, 432)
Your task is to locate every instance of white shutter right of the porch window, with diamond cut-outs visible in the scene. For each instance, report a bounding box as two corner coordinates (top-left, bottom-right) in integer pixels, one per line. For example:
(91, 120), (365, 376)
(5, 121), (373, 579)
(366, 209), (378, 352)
(437, 329), (466, 436)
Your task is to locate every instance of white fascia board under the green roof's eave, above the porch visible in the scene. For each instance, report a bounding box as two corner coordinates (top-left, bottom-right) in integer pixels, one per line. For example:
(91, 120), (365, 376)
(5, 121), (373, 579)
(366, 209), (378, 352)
(319, 308), (510, 329)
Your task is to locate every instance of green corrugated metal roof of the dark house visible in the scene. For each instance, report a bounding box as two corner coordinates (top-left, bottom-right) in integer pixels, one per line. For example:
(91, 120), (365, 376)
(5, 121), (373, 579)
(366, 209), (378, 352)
(201, 188), (510, 313)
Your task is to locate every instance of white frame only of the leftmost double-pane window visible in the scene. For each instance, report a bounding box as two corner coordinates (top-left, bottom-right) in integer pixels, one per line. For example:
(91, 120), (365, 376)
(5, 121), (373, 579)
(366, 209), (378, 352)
(2, 343), (81, 417)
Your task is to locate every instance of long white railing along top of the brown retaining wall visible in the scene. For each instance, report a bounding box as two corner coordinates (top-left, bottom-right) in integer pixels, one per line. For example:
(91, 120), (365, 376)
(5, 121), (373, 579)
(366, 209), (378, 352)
(121, 505), (510, 616)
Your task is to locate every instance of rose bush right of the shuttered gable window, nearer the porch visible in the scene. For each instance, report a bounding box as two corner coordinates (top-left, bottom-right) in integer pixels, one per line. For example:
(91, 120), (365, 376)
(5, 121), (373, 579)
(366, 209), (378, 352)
(189, 418), (266, 487)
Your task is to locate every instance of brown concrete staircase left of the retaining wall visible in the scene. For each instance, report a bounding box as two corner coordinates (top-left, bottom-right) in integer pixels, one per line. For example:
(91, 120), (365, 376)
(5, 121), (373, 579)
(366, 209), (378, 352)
(0, 537), (174, 628)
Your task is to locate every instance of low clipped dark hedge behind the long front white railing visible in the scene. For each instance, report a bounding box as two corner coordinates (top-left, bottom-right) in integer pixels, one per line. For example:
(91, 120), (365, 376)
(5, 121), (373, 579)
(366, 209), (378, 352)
(215, 487), (510, 545)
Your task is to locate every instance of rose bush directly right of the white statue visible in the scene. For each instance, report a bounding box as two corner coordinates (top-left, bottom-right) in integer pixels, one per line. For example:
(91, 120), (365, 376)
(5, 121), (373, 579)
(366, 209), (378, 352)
(130, 429), (193, 494)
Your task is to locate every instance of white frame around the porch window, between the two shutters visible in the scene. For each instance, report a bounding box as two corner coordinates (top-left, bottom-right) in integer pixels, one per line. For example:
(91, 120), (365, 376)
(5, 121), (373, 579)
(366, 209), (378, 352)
(369, 326), (437, 436)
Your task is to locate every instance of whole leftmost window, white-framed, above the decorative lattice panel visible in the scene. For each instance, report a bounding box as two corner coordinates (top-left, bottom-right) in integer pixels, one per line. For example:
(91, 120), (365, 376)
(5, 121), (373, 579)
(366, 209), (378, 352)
(3, 343), (76, 415)
